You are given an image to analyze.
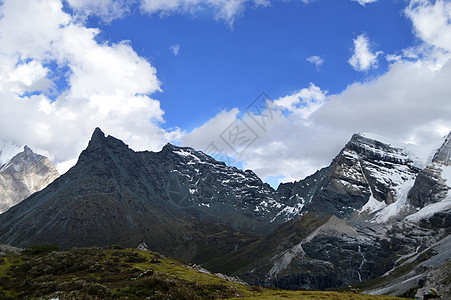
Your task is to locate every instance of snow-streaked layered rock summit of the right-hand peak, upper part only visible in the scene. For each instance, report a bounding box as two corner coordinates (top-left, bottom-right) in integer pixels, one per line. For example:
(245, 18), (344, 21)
(277, 134), (420, 221)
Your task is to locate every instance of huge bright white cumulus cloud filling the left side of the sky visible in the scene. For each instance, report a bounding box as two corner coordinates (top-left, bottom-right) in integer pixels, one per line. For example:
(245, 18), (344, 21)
(0, 0), (180, 171)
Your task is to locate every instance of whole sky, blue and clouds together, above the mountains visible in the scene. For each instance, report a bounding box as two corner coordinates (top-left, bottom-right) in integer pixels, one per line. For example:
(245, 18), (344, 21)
(0, 0), (451, 186)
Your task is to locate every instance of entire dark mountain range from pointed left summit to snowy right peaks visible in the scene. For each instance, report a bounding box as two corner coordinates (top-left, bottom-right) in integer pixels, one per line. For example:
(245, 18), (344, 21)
(0, 129), (451, 295)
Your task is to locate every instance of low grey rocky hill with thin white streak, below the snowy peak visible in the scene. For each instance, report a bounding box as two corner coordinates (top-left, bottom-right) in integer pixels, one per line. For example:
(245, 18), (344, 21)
(237, 213), (394, 289)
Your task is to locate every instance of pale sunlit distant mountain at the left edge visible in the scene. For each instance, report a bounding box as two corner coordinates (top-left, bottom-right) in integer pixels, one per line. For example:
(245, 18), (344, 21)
(0, 143), (59, 213)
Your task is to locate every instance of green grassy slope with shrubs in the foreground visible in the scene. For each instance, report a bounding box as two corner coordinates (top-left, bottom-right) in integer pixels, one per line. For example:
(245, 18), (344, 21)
(0, 248), (406, 300)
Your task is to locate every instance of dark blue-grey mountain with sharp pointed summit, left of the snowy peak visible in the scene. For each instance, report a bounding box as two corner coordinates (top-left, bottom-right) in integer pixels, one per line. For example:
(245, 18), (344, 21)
(0, 129), (282, 259)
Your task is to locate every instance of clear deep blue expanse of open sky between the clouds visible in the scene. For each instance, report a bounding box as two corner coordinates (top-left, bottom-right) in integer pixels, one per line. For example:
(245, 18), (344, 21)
(87, 0), (414, 131)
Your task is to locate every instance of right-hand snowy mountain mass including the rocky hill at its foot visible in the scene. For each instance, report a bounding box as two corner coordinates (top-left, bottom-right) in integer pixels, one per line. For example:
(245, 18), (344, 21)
(224, 134), (451, 297)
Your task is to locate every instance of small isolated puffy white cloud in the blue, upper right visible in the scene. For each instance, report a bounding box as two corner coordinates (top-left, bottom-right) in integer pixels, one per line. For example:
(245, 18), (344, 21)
(348, 34), (382, 71)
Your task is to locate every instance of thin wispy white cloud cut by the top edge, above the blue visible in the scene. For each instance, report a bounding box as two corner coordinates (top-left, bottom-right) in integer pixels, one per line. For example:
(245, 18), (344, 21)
(141, 0), (270, 25)
